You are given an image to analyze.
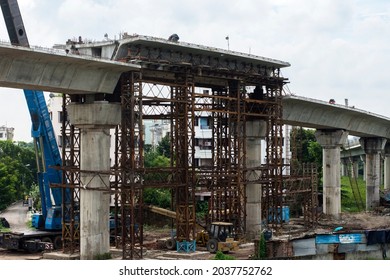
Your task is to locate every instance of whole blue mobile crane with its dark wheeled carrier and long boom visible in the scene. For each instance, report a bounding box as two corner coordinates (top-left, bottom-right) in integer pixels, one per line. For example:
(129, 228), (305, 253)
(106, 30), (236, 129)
(0, 0), (115, 254)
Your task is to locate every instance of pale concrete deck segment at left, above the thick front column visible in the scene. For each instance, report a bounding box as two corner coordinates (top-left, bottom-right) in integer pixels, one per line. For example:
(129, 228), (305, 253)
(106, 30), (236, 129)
(0, 43), (140, 94)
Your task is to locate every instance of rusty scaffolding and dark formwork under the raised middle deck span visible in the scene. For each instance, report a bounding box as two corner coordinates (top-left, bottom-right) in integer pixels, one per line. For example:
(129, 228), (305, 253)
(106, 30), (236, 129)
(52, 37), (316, 259)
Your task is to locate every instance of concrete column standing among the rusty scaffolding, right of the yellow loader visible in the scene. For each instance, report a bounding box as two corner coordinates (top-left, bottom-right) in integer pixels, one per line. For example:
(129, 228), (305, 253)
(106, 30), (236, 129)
(246, 120), (267, 239)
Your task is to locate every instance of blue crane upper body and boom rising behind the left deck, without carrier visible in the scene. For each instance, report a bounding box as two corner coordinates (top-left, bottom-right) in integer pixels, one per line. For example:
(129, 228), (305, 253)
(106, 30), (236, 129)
(0, 0), (62, 230)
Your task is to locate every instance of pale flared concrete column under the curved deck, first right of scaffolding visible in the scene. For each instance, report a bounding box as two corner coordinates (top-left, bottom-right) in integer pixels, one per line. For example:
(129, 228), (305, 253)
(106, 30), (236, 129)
(315, 130), (348, 217)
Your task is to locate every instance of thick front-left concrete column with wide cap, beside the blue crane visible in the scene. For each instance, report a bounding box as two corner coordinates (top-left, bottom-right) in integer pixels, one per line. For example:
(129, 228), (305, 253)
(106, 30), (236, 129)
(67, 101), (121, 260)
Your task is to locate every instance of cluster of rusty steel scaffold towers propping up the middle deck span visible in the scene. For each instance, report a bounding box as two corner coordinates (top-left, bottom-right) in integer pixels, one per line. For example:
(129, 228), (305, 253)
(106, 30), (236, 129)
(54, 72), (292, 259)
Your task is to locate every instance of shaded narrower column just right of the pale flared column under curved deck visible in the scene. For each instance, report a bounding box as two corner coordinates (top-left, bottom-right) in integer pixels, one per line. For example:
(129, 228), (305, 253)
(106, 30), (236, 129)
(360, 138), (386, 210)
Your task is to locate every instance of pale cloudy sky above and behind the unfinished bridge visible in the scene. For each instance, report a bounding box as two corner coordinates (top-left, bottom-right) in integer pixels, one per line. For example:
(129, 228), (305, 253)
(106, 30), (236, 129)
(0, 0), (390, 142)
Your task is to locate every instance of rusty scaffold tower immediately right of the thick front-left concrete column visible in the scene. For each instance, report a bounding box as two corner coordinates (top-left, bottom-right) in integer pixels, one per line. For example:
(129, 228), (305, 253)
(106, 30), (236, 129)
(111, 72), (143, 259)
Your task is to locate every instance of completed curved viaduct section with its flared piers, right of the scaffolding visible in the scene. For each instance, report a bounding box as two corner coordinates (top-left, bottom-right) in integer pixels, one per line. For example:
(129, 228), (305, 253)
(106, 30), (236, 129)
(282, 96), (390, 216)
